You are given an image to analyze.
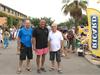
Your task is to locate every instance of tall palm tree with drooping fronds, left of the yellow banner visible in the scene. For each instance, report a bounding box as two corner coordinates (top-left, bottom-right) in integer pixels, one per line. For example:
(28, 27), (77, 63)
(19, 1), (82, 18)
(62, 0), (87, 32)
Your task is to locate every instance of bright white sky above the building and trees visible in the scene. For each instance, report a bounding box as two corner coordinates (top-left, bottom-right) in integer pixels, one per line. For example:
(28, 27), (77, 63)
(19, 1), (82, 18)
(0, 0), (100, 23)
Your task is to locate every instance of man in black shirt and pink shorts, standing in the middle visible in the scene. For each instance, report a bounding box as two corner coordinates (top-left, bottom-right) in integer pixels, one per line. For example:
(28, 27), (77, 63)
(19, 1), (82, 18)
(33, 20), (49, 73)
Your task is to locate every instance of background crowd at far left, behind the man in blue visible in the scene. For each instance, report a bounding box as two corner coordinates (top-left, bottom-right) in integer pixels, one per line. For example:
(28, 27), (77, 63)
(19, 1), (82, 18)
(0, 27), (17, 49)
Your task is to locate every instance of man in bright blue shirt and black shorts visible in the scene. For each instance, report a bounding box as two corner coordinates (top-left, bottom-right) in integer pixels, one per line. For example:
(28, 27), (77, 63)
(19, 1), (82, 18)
(18, 19), (33, 73)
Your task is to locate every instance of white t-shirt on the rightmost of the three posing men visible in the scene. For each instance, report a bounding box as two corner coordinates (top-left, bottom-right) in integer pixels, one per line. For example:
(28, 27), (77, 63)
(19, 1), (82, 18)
(48, 30), (63, 51)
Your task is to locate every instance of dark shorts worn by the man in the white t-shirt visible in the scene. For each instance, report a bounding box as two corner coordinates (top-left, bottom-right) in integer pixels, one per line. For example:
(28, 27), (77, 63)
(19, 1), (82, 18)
(50, 50), (61, 62)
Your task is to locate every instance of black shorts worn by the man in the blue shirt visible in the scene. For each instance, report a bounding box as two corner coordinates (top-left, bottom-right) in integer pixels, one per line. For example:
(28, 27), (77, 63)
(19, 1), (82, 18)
(20, 47), (33, 60)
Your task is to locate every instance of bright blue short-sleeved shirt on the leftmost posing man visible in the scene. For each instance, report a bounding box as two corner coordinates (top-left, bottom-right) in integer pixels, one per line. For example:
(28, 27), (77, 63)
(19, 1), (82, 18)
(18, 27), (33, 47)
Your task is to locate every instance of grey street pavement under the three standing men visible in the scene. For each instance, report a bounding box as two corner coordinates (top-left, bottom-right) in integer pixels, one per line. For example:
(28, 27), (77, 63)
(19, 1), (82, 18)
(0, 41), (100, 75)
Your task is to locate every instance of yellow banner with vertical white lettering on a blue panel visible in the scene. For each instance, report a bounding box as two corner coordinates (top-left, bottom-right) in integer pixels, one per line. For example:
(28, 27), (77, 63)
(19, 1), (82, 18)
(87, 8), (100, 56)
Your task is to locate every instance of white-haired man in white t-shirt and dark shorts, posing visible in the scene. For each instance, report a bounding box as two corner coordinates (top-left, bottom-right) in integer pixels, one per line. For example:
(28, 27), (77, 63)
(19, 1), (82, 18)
(48, 23), (63, 73)
